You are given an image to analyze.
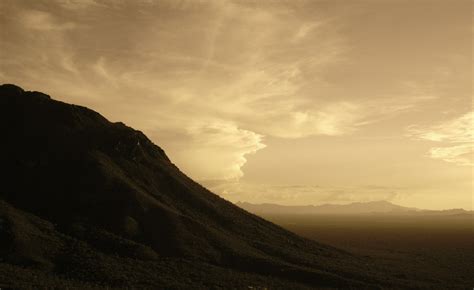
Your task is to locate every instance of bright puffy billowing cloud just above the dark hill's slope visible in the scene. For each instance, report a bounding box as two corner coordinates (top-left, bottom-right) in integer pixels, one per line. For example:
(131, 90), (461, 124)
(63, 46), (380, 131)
(156, 120), (266, 182)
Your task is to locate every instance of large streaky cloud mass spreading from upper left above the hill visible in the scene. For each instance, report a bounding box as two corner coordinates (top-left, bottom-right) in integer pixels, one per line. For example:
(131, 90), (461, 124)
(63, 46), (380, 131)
(0, 0), (462, 185)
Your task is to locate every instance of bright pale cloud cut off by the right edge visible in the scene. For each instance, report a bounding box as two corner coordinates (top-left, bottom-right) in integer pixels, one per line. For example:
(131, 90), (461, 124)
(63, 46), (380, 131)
(408, 111), (474, 166)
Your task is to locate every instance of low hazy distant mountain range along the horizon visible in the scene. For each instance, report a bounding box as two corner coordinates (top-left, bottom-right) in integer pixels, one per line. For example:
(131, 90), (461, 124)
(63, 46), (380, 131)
(236, 201), (472, 215)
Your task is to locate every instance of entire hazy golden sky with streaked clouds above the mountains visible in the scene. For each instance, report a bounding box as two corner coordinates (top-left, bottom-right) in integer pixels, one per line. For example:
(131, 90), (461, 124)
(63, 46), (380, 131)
(0, 0), (474, 209)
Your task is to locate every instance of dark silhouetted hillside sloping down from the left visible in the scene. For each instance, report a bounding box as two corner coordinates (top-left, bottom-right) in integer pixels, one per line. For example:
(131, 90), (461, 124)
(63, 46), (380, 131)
(0, 85), (472, 289)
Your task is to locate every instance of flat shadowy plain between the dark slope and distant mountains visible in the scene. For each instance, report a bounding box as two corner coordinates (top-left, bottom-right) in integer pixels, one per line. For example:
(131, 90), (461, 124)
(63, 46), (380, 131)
(254, 213), (474, 289)
